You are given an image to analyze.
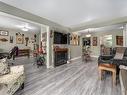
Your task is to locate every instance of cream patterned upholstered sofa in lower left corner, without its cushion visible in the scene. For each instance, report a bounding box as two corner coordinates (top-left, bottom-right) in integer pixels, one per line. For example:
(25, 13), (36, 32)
(0, 65), (25, 95)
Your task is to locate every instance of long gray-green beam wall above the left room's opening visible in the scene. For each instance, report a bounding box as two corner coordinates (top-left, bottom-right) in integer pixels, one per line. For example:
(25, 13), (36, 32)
(0, 1), (69, 31)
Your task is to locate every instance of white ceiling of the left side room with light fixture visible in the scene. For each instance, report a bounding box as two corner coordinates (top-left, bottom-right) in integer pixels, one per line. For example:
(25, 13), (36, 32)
(0, 12), (41, 33)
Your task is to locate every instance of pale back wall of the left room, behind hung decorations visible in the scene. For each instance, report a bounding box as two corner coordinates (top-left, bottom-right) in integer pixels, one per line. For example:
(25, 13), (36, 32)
(0, 28), (38, 51)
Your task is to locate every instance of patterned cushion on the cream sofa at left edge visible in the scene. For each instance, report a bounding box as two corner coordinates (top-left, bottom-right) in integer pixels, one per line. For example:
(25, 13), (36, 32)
(0, 58), (10, 76)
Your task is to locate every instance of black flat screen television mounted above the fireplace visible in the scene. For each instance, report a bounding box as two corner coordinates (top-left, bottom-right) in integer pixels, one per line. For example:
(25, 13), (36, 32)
(54, 31), (67, 44)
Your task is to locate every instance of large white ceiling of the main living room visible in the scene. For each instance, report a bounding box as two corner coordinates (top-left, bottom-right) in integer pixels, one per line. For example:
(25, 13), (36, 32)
(0, 0), (127, 27)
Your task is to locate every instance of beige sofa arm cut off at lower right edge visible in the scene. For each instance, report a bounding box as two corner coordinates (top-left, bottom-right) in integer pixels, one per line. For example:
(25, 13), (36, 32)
(119, 65), (127, 95)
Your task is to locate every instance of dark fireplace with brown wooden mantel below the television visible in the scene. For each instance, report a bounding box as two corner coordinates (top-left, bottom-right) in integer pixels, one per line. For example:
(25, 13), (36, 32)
(54, 48), (68, 66)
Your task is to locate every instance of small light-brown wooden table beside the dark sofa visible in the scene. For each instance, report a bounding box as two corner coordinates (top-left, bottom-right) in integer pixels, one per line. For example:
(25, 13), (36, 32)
(98, 64), (116, 84)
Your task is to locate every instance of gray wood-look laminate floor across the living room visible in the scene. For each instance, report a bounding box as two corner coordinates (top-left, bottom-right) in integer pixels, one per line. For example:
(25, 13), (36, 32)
(12, 58), (121, 95)
